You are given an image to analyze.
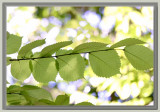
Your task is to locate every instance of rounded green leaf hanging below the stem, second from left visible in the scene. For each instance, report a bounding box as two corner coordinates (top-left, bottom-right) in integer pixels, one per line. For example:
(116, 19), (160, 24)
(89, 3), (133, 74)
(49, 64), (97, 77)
(32, 58), (57, 83)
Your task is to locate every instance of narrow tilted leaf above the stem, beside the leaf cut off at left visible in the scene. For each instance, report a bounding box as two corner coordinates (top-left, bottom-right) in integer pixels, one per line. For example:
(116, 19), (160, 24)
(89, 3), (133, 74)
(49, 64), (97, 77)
(18, 39), (45, 58)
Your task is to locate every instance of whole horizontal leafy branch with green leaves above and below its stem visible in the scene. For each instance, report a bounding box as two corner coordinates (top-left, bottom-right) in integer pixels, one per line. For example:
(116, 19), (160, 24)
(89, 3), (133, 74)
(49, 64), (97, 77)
(7, 33), (153, 83)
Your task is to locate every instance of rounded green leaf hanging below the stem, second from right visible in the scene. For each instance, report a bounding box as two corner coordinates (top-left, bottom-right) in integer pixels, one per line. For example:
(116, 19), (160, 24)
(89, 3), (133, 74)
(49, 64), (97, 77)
(89, 50), (120, 78)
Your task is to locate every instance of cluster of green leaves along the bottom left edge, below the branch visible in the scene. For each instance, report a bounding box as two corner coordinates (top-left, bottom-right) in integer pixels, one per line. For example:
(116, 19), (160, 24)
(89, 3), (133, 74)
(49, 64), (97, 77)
(7, 85), (93, 106)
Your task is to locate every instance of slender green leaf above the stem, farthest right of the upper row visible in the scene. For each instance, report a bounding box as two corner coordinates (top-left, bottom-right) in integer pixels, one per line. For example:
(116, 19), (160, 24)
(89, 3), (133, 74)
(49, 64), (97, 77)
(111, 38), (145, 48)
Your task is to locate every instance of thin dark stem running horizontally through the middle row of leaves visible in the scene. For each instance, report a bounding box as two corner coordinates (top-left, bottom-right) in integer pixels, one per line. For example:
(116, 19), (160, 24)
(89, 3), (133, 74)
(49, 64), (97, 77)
(9, 49), (124, 61)
